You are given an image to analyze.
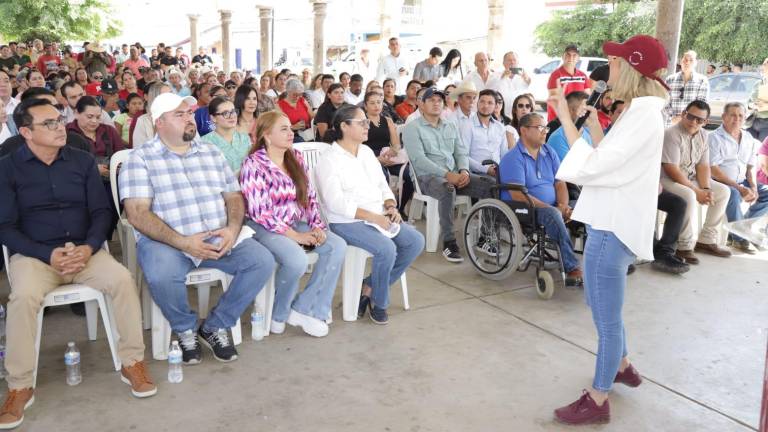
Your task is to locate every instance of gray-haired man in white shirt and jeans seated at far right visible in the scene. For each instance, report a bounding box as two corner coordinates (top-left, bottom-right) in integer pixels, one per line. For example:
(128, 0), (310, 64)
(708, 102), (768, 253)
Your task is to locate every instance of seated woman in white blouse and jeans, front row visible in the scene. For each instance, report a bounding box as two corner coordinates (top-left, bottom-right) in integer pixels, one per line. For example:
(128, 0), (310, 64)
(315, 105), (424, 324)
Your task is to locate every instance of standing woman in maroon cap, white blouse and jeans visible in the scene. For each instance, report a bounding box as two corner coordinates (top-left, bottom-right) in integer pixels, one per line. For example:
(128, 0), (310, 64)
(549, 35), (668, 424)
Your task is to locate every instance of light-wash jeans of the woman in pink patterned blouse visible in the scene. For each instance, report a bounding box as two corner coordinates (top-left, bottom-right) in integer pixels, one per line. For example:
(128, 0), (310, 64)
(247, 220), (347, 322)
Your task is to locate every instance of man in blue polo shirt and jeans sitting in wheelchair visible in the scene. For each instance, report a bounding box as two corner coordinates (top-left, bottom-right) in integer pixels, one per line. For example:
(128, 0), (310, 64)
(499, 113), (582, 284)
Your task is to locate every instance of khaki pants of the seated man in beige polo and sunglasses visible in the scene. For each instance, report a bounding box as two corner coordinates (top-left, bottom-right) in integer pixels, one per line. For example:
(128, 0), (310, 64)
(661, 178), (731, 250)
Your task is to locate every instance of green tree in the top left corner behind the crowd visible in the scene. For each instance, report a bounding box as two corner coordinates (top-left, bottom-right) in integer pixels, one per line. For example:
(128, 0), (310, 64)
(0, 0), (121, 41)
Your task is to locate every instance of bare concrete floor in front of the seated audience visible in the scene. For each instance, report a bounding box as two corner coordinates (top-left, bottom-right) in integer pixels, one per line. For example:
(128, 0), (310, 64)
(0, 226), (768, 432)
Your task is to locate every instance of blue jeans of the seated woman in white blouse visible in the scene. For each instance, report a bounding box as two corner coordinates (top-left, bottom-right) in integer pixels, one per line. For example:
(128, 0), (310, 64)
(331, 222), (424, 309)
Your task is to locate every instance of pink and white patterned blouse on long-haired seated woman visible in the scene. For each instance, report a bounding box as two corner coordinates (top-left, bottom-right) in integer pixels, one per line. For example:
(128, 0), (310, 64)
(240, 149), (325, 234)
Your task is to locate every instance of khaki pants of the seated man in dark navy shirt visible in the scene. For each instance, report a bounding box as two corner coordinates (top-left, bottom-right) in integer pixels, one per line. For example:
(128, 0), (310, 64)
(5, 250), (144, 389)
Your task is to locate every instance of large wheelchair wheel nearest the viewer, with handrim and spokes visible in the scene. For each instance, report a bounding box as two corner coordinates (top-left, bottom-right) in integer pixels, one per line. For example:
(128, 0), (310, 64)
(463, 199), (525, 280)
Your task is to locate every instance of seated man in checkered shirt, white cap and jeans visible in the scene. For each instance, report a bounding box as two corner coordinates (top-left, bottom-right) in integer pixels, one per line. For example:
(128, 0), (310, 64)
(118, 93), (275, 364)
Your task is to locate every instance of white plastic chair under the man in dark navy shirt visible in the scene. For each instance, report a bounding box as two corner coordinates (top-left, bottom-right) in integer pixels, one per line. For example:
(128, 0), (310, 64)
(3, 243), (121, 388)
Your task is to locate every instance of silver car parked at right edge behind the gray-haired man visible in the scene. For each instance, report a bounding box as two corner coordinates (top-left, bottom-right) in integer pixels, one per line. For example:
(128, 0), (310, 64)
(707, 72), (761, 129)
